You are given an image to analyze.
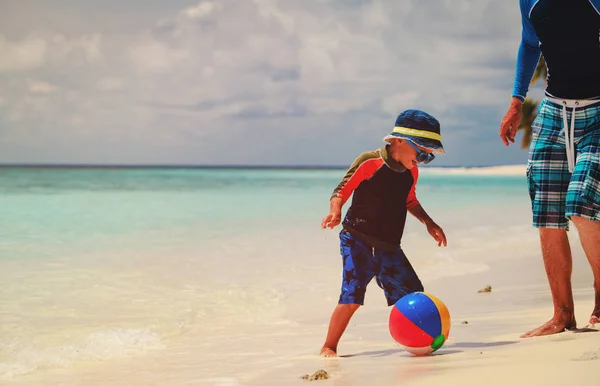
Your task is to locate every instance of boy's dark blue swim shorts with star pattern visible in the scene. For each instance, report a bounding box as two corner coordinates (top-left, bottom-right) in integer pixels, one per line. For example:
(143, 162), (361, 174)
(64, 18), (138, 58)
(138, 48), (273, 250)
(338, 229), (423, 306)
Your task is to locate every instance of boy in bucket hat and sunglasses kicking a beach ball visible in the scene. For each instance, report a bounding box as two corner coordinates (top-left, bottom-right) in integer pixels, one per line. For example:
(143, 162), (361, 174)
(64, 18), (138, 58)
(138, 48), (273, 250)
(321, 110), (447, 357)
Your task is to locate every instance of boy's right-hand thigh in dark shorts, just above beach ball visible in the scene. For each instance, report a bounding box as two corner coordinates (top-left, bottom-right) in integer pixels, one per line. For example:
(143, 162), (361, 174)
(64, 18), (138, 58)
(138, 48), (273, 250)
(375, 247), (424, 306)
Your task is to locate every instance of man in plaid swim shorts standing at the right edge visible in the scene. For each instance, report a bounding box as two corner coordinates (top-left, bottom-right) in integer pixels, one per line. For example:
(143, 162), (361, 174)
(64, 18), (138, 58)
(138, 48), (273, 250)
(500, 0), (600, 337)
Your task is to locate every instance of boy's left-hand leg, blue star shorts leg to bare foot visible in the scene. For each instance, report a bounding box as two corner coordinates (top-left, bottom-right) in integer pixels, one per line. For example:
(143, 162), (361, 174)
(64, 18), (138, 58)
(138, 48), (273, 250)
(321, 229), (375, 357)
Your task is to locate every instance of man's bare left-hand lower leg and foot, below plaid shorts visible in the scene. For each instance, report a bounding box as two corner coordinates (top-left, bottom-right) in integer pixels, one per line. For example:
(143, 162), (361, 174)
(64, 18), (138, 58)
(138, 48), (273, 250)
(521, 228), (577, 338)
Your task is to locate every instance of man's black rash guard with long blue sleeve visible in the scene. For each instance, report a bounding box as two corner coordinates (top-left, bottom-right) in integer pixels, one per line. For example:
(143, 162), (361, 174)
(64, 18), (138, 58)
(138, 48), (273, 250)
(512, 0), (600, 100)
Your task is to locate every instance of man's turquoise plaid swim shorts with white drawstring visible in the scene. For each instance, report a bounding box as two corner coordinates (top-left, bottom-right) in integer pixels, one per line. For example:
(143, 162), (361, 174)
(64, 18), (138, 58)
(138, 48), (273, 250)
(527, 98), (600, 229)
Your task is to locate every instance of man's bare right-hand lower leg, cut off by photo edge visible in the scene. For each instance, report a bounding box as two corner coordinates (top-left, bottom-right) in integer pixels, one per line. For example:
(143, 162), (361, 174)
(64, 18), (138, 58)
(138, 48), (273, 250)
(571, 217), (600, 325)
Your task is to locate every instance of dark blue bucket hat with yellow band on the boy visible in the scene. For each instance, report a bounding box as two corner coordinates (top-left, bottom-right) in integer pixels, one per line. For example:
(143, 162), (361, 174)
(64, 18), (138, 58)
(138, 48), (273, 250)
(384, 110), (444, 154)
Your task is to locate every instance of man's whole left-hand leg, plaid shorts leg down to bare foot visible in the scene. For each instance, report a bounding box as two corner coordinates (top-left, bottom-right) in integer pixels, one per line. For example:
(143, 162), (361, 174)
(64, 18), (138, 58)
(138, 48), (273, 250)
(521, 99), (576, 337)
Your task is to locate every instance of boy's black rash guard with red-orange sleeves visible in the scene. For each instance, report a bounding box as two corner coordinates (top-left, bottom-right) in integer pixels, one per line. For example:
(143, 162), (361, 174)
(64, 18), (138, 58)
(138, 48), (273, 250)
(331, 147), (419, 250)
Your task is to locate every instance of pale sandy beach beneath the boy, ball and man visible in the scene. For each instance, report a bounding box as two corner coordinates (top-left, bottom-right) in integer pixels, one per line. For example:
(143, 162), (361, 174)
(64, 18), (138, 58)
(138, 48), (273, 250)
(3, 232), (600, 386)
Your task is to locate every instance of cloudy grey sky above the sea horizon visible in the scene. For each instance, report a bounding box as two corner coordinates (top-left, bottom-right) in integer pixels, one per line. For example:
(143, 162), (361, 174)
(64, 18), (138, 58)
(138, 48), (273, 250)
(0, 0), (543, 166)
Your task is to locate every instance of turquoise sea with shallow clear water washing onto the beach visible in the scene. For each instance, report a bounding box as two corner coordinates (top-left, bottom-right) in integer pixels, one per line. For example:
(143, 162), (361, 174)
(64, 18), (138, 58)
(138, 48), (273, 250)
(0, 167), (537, 383)
